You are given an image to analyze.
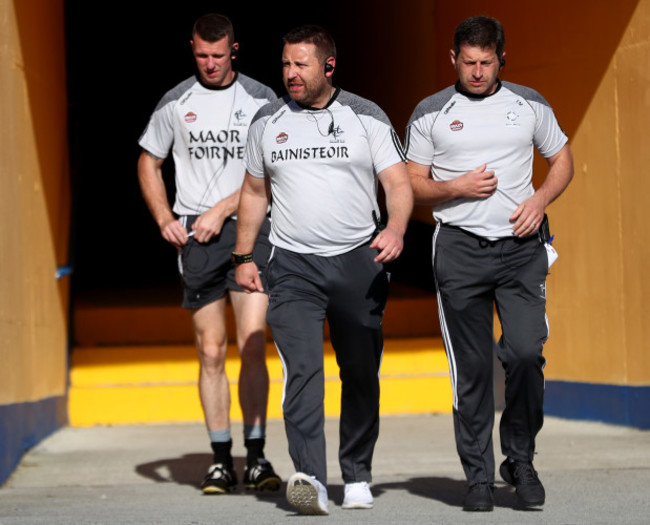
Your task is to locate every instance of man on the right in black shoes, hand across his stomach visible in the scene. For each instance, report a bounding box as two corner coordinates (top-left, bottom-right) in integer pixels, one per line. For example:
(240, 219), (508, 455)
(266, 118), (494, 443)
(406, 16), (573, 511)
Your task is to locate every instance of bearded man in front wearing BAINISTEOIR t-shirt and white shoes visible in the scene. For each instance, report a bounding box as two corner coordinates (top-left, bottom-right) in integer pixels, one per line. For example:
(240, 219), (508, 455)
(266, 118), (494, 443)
(233, 26), (412, 514)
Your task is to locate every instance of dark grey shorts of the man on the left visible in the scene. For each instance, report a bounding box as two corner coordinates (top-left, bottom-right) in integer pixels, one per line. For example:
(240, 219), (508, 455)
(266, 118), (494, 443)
(178, 215), (271, 309)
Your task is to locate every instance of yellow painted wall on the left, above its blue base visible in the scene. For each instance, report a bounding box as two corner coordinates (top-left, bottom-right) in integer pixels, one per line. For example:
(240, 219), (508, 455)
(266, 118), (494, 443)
(0, 0), (70, 404)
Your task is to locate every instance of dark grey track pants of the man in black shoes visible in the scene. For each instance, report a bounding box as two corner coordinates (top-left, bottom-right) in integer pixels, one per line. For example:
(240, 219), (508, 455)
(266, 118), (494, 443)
(433, 224), (548, 485)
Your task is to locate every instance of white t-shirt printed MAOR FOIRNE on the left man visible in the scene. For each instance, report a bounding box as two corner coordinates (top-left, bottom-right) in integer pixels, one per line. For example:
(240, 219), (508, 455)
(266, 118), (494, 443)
(139, 73), (277, 215)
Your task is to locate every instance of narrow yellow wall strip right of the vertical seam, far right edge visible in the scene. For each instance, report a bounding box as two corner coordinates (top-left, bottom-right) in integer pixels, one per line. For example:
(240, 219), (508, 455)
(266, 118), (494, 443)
(610, 1), (650, 384)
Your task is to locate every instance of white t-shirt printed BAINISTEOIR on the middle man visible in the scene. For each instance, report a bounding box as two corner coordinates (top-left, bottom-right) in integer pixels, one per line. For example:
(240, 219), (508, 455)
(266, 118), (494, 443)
(245, 90), (404, 256)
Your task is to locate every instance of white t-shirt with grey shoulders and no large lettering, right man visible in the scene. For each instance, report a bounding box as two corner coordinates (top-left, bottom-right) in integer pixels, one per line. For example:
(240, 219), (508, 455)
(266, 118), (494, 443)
(406, 82), (568, 240)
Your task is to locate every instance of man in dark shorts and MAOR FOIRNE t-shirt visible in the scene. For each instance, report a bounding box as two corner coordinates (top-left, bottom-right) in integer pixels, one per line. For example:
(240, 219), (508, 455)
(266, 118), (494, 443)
(138, 14), (281, 494)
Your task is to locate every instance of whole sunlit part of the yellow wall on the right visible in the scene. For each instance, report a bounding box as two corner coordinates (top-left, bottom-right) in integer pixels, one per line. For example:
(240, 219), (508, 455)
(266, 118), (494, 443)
(548, 0), (650, 385)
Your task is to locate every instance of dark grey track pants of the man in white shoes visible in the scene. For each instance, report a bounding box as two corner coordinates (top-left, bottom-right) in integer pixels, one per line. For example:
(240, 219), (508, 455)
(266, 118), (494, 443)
(267, 244), (388, 484)
